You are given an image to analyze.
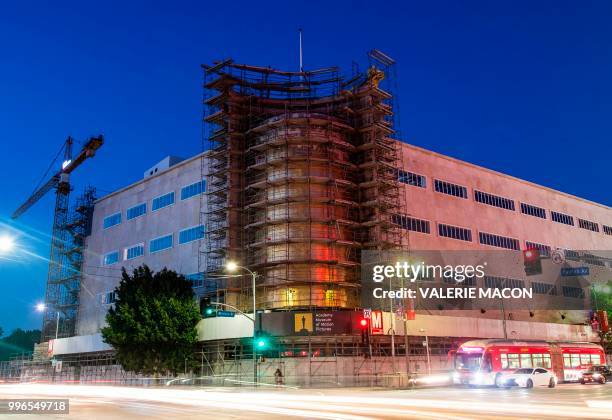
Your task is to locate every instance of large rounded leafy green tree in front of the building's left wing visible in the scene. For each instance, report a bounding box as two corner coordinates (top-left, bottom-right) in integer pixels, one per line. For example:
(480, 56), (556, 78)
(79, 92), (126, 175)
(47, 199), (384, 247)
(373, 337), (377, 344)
(102, 265), (201, 378)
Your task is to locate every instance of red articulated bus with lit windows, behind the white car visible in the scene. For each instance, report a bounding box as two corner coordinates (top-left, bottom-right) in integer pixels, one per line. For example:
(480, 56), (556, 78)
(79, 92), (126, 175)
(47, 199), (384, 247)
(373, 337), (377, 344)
(449, 339), (606, 385)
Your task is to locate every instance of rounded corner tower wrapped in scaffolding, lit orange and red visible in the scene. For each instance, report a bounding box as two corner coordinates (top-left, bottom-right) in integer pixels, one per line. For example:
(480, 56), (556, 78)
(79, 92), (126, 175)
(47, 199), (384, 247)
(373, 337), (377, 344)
(201, 50), (403, 310)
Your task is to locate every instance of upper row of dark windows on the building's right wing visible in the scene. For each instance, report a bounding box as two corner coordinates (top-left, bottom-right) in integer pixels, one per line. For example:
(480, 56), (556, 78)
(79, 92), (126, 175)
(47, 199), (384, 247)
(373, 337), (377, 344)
(398, 169), (612, 235)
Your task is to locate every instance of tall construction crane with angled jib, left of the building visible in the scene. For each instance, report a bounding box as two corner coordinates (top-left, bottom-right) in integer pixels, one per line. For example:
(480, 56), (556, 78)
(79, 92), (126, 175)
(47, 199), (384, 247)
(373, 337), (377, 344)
(11, 135), (104, 341)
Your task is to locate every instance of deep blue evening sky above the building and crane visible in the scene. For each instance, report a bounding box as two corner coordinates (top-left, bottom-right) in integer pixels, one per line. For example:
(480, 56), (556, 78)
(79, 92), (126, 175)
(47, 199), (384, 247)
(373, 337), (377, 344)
(0, 0), (612, 330)
